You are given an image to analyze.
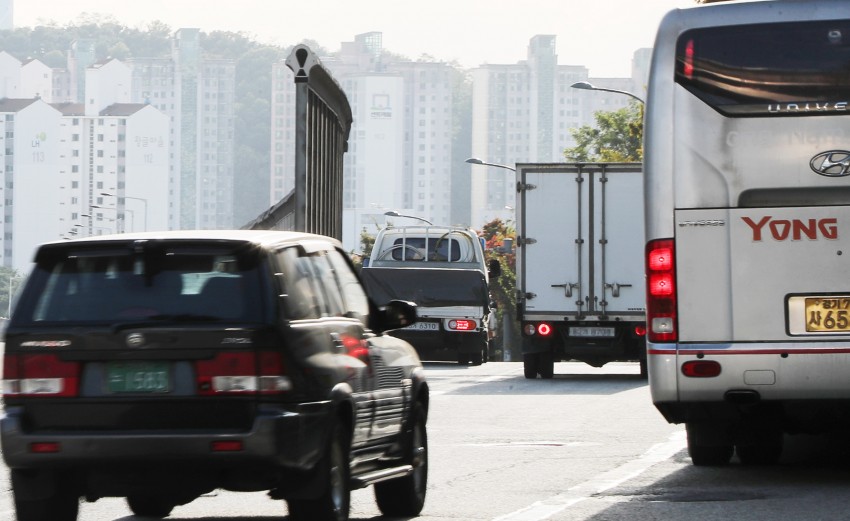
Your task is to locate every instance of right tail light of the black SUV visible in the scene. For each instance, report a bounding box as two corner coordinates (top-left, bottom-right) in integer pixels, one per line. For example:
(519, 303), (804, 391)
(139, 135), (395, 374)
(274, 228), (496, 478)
(195, 351), (292, 395)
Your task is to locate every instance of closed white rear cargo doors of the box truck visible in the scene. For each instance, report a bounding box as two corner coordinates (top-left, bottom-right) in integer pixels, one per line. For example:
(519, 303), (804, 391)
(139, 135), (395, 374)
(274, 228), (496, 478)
(517, 164), (644, 318)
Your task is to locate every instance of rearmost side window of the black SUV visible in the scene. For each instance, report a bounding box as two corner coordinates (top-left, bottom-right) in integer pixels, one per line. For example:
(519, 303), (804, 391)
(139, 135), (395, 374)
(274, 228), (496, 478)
(277, 247), (325, 320)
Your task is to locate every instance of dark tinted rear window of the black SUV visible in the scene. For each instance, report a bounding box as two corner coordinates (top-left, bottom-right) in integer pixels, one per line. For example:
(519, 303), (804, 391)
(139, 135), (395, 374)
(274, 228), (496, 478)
(15, 243), (261, 325)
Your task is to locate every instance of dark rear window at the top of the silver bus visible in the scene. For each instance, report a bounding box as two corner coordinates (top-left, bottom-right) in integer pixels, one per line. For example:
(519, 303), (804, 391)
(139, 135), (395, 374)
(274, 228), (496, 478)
(675, 20), (850, 117)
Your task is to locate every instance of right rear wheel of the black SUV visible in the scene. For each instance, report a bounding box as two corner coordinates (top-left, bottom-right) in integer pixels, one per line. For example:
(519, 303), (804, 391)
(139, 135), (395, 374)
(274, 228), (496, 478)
(287, 424), (351, 521)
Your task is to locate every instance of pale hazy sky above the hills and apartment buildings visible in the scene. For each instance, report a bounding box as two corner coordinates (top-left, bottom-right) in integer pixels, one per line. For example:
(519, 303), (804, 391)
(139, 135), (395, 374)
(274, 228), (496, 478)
(14, 0), (696, 77)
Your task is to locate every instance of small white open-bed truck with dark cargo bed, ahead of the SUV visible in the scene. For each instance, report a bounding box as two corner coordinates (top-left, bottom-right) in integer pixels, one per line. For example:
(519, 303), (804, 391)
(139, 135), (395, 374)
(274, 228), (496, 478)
(361, 225), (500, 365)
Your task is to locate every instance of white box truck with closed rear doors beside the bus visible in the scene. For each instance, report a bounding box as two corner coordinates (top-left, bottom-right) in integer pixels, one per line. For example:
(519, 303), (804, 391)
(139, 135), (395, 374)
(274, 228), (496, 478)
(516, 163), (646, 378)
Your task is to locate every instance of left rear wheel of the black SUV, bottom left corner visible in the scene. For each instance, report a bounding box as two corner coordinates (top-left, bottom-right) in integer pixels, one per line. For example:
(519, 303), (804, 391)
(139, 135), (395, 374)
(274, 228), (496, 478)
(11, 469), (80, 521)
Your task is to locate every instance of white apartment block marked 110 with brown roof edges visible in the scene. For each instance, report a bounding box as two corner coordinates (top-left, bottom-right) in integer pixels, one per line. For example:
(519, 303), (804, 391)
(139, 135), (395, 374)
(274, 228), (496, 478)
(55, 60), (169, 237)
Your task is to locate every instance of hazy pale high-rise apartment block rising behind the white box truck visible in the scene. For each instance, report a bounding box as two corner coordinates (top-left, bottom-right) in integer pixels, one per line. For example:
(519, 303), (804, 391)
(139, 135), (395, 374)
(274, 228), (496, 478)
(469, 35), (648, 226)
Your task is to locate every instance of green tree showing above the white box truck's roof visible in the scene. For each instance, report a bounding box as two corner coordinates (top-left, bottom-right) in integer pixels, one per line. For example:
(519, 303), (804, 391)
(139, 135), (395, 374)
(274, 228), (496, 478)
(564, 101), (643, 163)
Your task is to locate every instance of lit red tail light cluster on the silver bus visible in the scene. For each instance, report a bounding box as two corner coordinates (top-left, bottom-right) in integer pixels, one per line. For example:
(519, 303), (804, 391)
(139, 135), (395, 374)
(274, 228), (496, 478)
(646, 239), (678, 343)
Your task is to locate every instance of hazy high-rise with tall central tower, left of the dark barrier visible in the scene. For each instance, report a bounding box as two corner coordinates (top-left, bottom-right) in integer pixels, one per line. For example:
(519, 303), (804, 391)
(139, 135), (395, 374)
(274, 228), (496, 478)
(128, 28), (236, 229)
